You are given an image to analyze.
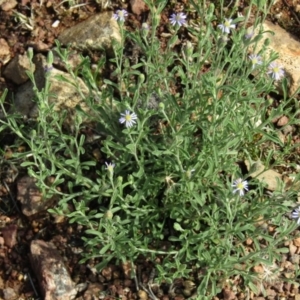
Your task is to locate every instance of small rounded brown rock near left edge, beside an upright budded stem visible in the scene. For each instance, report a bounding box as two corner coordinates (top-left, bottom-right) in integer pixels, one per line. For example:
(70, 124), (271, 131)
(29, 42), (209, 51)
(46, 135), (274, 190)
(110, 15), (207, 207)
(3, 54), (35, 84)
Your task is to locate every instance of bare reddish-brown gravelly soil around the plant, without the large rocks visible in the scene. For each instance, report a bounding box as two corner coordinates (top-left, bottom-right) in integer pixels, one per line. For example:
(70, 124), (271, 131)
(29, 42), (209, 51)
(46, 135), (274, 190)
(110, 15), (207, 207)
(0, 0), (300, 300)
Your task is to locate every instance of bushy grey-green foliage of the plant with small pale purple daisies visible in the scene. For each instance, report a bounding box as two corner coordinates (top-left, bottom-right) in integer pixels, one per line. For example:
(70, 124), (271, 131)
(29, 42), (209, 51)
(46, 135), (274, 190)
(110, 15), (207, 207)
(2, 1), (295, 296)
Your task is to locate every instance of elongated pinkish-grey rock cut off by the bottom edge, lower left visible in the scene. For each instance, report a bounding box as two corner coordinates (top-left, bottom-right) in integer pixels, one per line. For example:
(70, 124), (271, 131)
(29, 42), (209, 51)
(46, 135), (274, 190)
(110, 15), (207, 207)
(30, 240), (77, 300)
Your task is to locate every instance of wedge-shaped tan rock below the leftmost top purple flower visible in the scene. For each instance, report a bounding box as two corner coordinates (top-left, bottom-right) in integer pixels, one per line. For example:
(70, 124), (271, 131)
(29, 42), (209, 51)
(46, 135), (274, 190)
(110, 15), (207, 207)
(58, 12), (121, 52)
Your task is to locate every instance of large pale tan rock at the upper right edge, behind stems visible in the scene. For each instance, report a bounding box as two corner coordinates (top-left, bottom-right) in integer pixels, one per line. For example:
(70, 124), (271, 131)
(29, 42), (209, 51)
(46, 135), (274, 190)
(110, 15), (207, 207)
(251, 21), (300, 95)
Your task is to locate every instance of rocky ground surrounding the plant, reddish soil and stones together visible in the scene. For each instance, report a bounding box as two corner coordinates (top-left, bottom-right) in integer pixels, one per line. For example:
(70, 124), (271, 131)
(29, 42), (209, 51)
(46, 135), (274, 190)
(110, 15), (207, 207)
(0, 0), (300, 300)
